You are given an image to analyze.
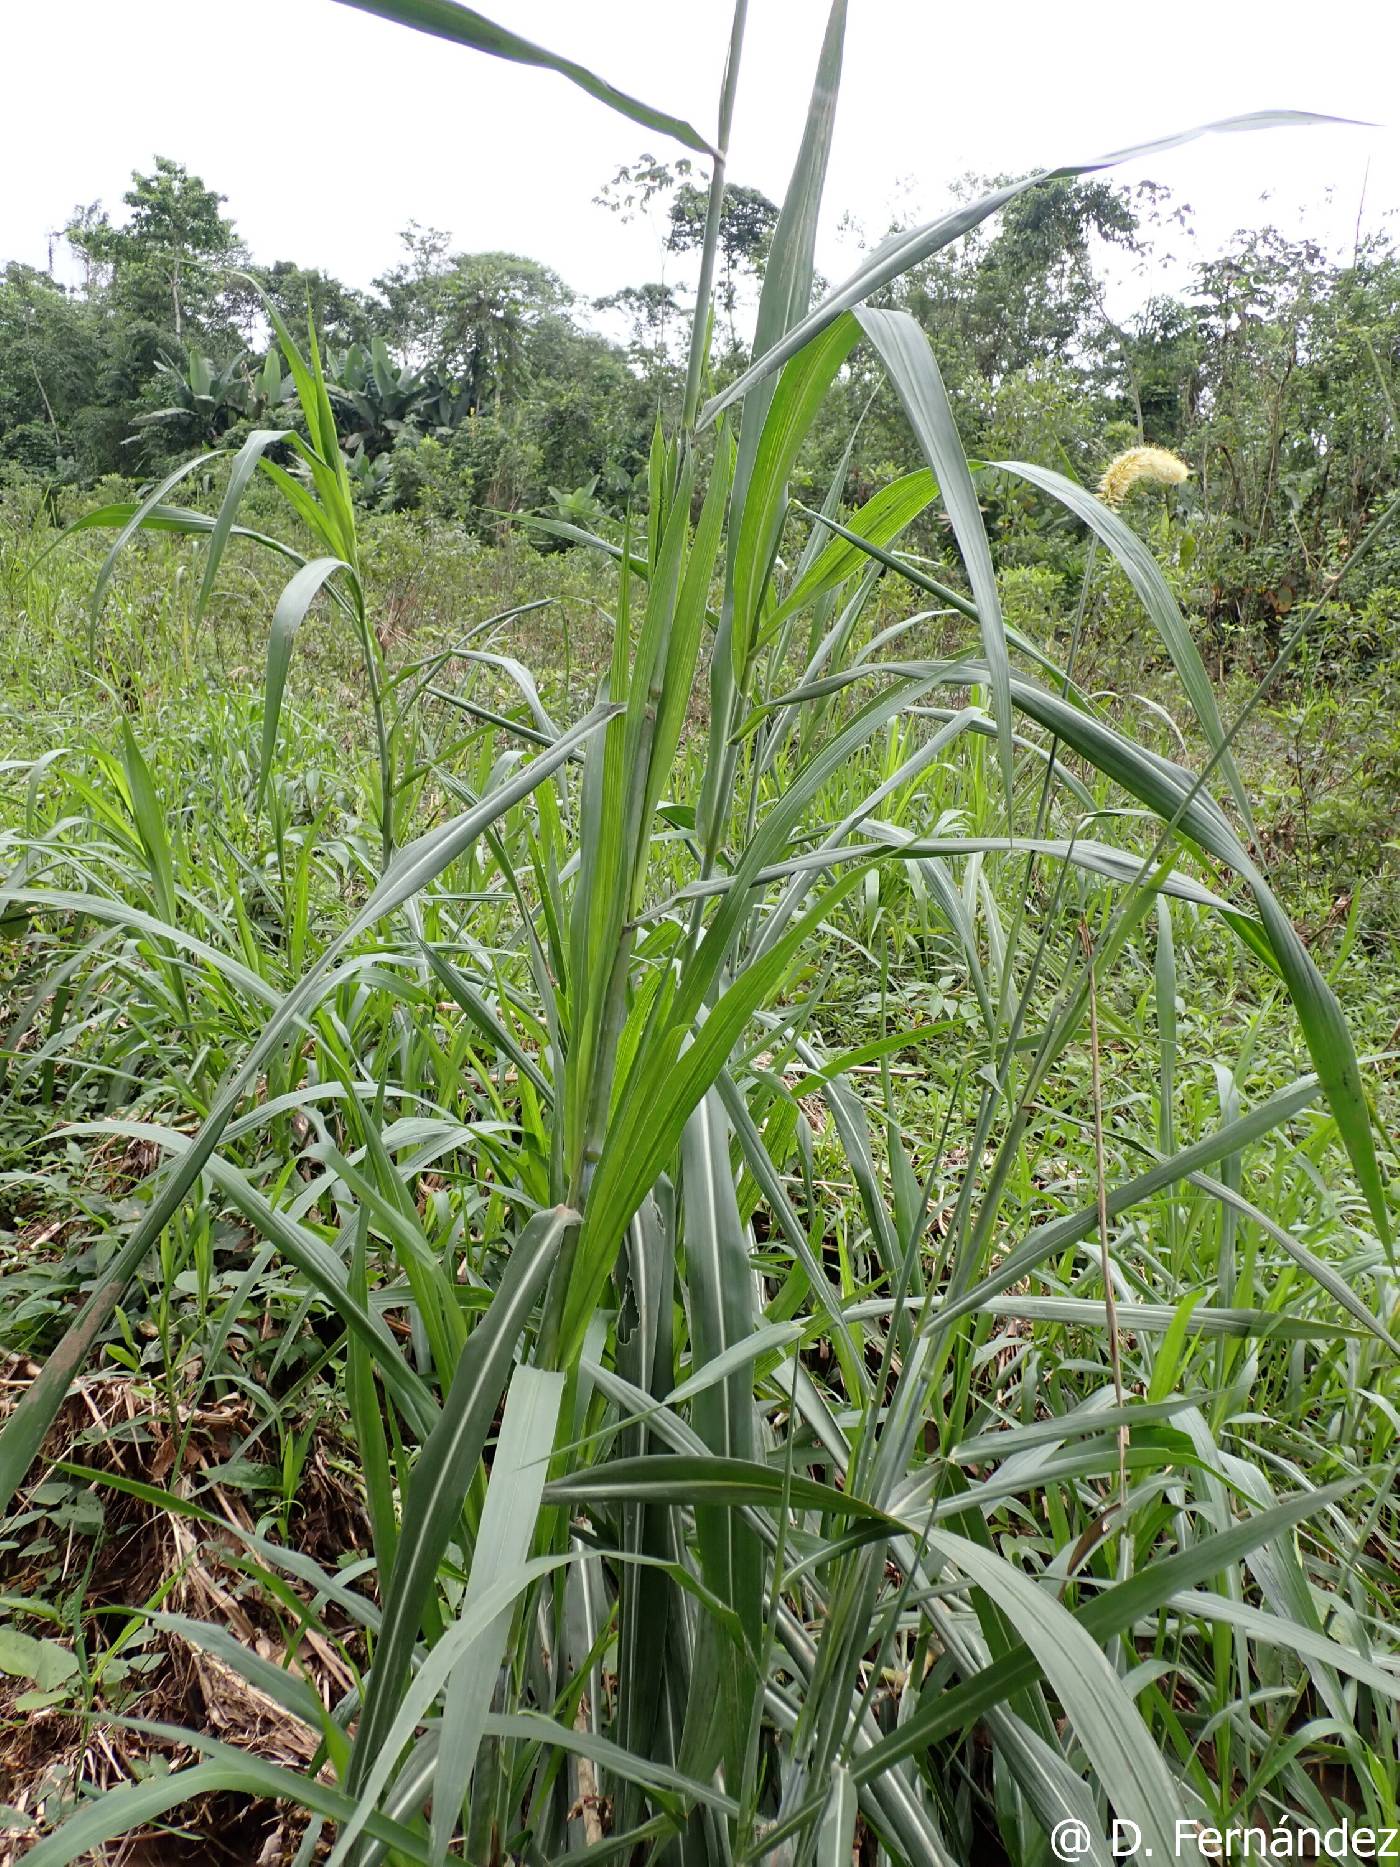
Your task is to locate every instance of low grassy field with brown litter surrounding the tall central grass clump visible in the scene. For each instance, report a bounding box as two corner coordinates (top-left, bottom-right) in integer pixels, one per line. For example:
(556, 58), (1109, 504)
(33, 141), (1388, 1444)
(0, 459), (1400, 1860)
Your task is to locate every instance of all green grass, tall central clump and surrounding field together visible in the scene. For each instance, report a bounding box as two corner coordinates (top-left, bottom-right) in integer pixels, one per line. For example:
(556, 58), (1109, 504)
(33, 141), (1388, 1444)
(0, 0), (1400, 1867)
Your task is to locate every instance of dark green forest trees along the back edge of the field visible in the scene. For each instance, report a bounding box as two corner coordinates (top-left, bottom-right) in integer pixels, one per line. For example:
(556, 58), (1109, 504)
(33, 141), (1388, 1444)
(10, 153), (1400, 639)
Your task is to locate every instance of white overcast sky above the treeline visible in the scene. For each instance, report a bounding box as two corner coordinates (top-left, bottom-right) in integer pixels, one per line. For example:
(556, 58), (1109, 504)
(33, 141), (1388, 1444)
(0, 0), (1400, 321)
